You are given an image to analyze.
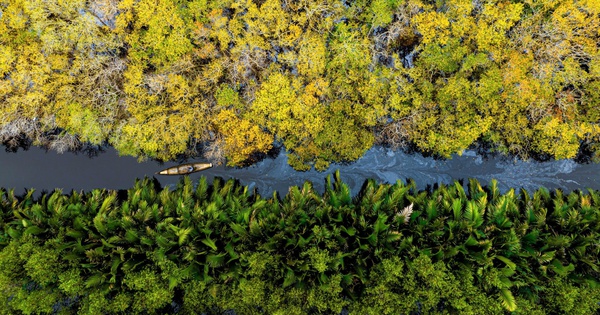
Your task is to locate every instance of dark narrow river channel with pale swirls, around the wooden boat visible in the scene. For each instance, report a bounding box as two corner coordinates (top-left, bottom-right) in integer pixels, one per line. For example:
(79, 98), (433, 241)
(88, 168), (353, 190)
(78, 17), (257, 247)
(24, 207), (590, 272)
(0, 147), (600, 197)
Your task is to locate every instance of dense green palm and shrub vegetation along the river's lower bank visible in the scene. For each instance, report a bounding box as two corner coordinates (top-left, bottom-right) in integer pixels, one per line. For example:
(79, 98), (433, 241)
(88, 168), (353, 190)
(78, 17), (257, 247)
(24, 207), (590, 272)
(0, 174), (600, 315)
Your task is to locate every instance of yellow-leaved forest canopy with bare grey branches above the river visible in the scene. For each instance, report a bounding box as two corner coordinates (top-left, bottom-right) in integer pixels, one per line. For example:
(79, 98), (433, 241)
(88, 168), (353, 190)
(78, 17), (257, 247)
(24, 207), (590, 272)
(0, 0), (600, 169)
